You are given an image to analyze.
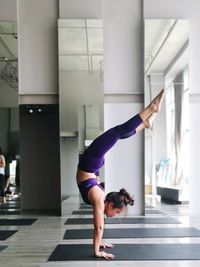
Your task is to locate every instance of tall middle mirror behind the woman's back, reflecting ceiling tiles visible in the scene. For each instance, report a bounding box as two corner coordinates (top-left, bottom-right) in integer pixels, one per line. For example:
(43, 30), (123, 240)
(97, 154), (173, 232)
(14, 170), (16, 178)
(58, 19), (103, 214)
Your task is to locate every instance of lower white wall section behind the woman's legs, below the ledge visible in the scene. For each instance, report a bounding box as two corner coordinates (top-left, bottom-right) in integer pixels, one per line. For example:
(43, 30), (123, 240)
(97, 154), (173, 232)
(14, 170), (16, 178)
(104, 103), (144, 217)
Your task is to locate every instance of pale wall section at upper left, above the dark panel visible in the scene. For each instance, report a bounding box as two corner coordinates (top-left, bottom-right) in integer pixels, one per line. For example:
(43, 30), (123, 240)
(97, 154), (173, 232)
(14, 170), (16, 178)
(17, 0), (58, 97)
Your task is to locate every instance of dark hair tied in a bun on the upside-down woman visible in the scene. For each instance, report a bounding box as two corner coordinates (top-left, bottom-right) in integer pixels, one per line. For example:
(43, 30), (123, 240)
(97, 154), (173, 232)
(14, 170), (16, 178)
(105, 188), (134, 209)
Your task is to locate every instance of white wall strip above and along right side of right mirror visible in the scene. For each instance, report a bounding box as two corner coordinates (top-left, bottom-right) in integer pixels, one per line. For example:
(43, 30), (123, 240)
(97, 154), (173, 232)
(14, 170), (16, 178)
(143, 0), (200, 215)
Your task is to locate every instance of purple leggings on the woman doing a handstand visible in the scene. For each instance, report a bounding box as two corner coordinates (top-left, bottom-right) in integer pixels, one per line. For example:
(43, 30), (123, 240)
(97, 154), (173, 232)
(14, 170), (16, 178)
(78, 114), (143, 175)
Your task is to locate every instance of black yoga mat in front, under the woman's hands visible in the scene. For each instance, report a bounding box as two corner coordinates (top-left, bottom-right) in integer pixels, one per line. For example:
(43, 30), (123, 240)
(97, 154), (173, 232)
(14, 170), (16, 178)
(48, 244), (200, 261)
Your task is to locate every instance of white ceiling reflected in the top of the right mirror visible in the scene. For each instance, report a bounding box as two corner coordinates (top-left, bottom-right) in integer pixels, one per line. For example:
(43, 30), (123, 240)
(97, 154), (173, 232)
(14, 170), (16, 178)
(144, 19), (189, 74)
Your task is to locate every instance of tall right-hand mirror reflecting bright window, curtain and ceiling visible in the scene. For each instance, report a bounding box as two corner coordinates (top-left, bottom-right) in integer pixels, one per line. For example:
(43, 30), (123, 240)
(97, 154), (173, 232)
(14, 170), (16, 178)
(145, 19), (189, 206)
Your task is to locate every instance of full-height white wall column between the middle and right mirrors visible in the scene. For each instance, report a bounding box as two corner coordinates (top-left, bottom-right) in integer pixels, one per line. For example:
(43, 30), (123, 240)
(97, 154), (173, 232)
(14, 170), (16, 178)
(103, 0), (144, 214)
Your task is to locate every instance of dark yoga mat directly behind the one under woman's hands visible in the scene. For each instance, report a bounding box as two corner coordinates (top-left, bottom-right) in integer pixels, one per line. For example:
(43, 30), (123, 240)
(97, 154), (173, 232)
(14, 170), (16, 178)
(63, 227), (200, 239)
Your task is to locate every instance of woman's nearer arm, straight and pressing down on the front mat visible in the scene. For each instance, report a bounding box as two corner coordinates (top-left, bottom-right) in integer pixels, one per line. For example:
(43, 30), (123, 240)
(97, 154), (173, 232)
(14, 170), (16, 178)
(89, 188), (114, 259)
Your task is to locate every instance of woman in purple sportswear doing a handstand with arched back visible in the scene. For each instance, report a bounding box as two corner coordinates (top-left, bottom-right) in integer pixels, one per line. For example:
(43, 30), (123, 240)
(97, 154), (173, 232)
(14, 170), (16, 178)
(76, 89), (164, 259)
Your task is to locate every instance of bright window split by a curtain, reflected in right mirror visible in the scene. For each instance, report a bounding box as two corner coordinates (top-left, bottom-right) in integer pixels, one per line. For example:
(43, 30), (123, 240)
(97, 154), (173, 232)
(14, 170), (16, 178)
(166, 68), (189, 186)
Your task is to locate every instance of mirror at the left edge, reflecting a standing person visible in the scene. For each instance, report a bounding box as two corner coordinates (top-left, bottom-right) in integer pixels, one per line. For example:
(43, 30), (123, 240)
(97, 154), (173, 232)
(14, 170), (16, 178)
(0, 21), (21, 214)
